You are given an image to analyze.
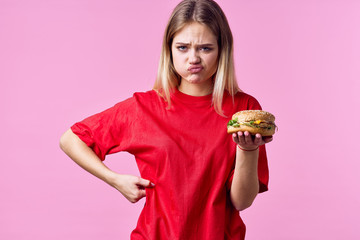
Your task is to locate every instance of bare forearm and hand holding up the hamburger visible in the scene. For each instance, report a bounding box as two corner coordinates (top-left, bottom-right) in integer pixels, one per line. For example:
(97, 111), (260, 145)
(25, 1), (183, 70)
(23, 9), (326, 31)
(230, 132), (272, 211)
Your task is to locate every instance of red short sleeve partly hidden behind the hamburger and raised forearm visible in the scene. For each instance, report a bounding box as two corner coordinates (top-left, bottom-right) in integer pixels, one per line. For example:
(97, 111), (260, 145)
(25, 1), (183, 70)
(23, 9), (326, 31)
(226, 95), (269, 193)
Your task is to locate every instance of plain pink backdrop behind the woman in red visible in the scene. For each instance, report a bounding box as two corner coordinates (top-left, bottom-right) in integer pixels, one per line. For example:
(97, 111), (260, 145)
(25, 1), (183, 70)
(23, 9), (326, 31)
(0, 0), (360, 240)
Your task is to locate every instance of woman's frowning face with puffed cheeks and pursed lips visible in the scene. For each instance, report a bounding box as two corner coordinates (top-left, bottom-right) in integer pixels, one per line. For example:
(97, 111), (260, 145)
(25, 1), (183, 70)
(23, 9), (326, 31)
(171, 22), (219, 88)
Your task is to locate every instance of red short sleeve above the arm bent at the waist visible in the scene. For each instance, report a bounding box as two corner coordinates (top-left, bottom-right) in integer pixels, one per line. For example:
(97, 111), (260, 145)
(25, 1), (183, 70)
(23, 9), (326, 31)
(71, 97), (136, 160)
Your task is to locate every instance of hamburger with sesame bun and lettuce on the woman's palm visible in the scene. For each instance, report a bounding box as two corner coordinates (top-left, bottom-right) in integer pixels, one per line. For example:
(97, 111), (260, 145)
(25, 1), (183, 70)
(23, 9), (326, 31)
(227, 110), (277, 136)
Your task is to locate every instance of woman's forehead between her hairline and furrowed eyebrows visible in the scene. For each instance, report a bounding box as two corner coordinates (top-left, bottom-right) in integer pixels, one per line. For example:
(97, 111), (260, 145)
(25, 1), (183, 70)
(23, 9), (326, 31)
(173, 22), (217, 44)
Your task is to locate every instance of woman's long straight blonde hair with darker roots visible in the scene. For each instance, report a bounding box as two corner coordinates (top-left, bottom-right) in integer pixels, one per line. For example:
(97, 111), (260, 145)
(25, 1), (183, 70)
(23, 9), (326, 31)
(154, 0), (240, 116)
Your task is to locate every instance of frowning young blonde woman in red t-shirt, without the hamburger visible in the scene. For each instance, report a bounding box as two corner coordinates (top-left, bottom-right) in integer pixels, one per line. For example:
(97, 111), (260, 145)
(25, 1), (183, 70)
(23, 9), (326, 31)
(60, 0), (272, 240)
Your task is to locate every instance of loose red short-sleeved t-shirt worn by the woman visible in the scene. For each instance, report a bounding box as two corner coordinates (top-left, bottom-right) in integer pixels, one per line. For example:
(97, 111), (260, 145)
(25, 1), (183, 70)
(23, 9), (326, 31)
(71, 90), (268, 240)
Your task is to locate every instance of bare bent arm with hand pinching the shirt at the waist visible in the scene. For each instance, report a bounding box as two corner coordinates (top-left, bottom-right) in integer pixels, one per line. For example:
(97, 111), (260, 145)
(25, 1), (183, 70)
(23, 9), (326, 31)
(60, 129), (154, 203)
